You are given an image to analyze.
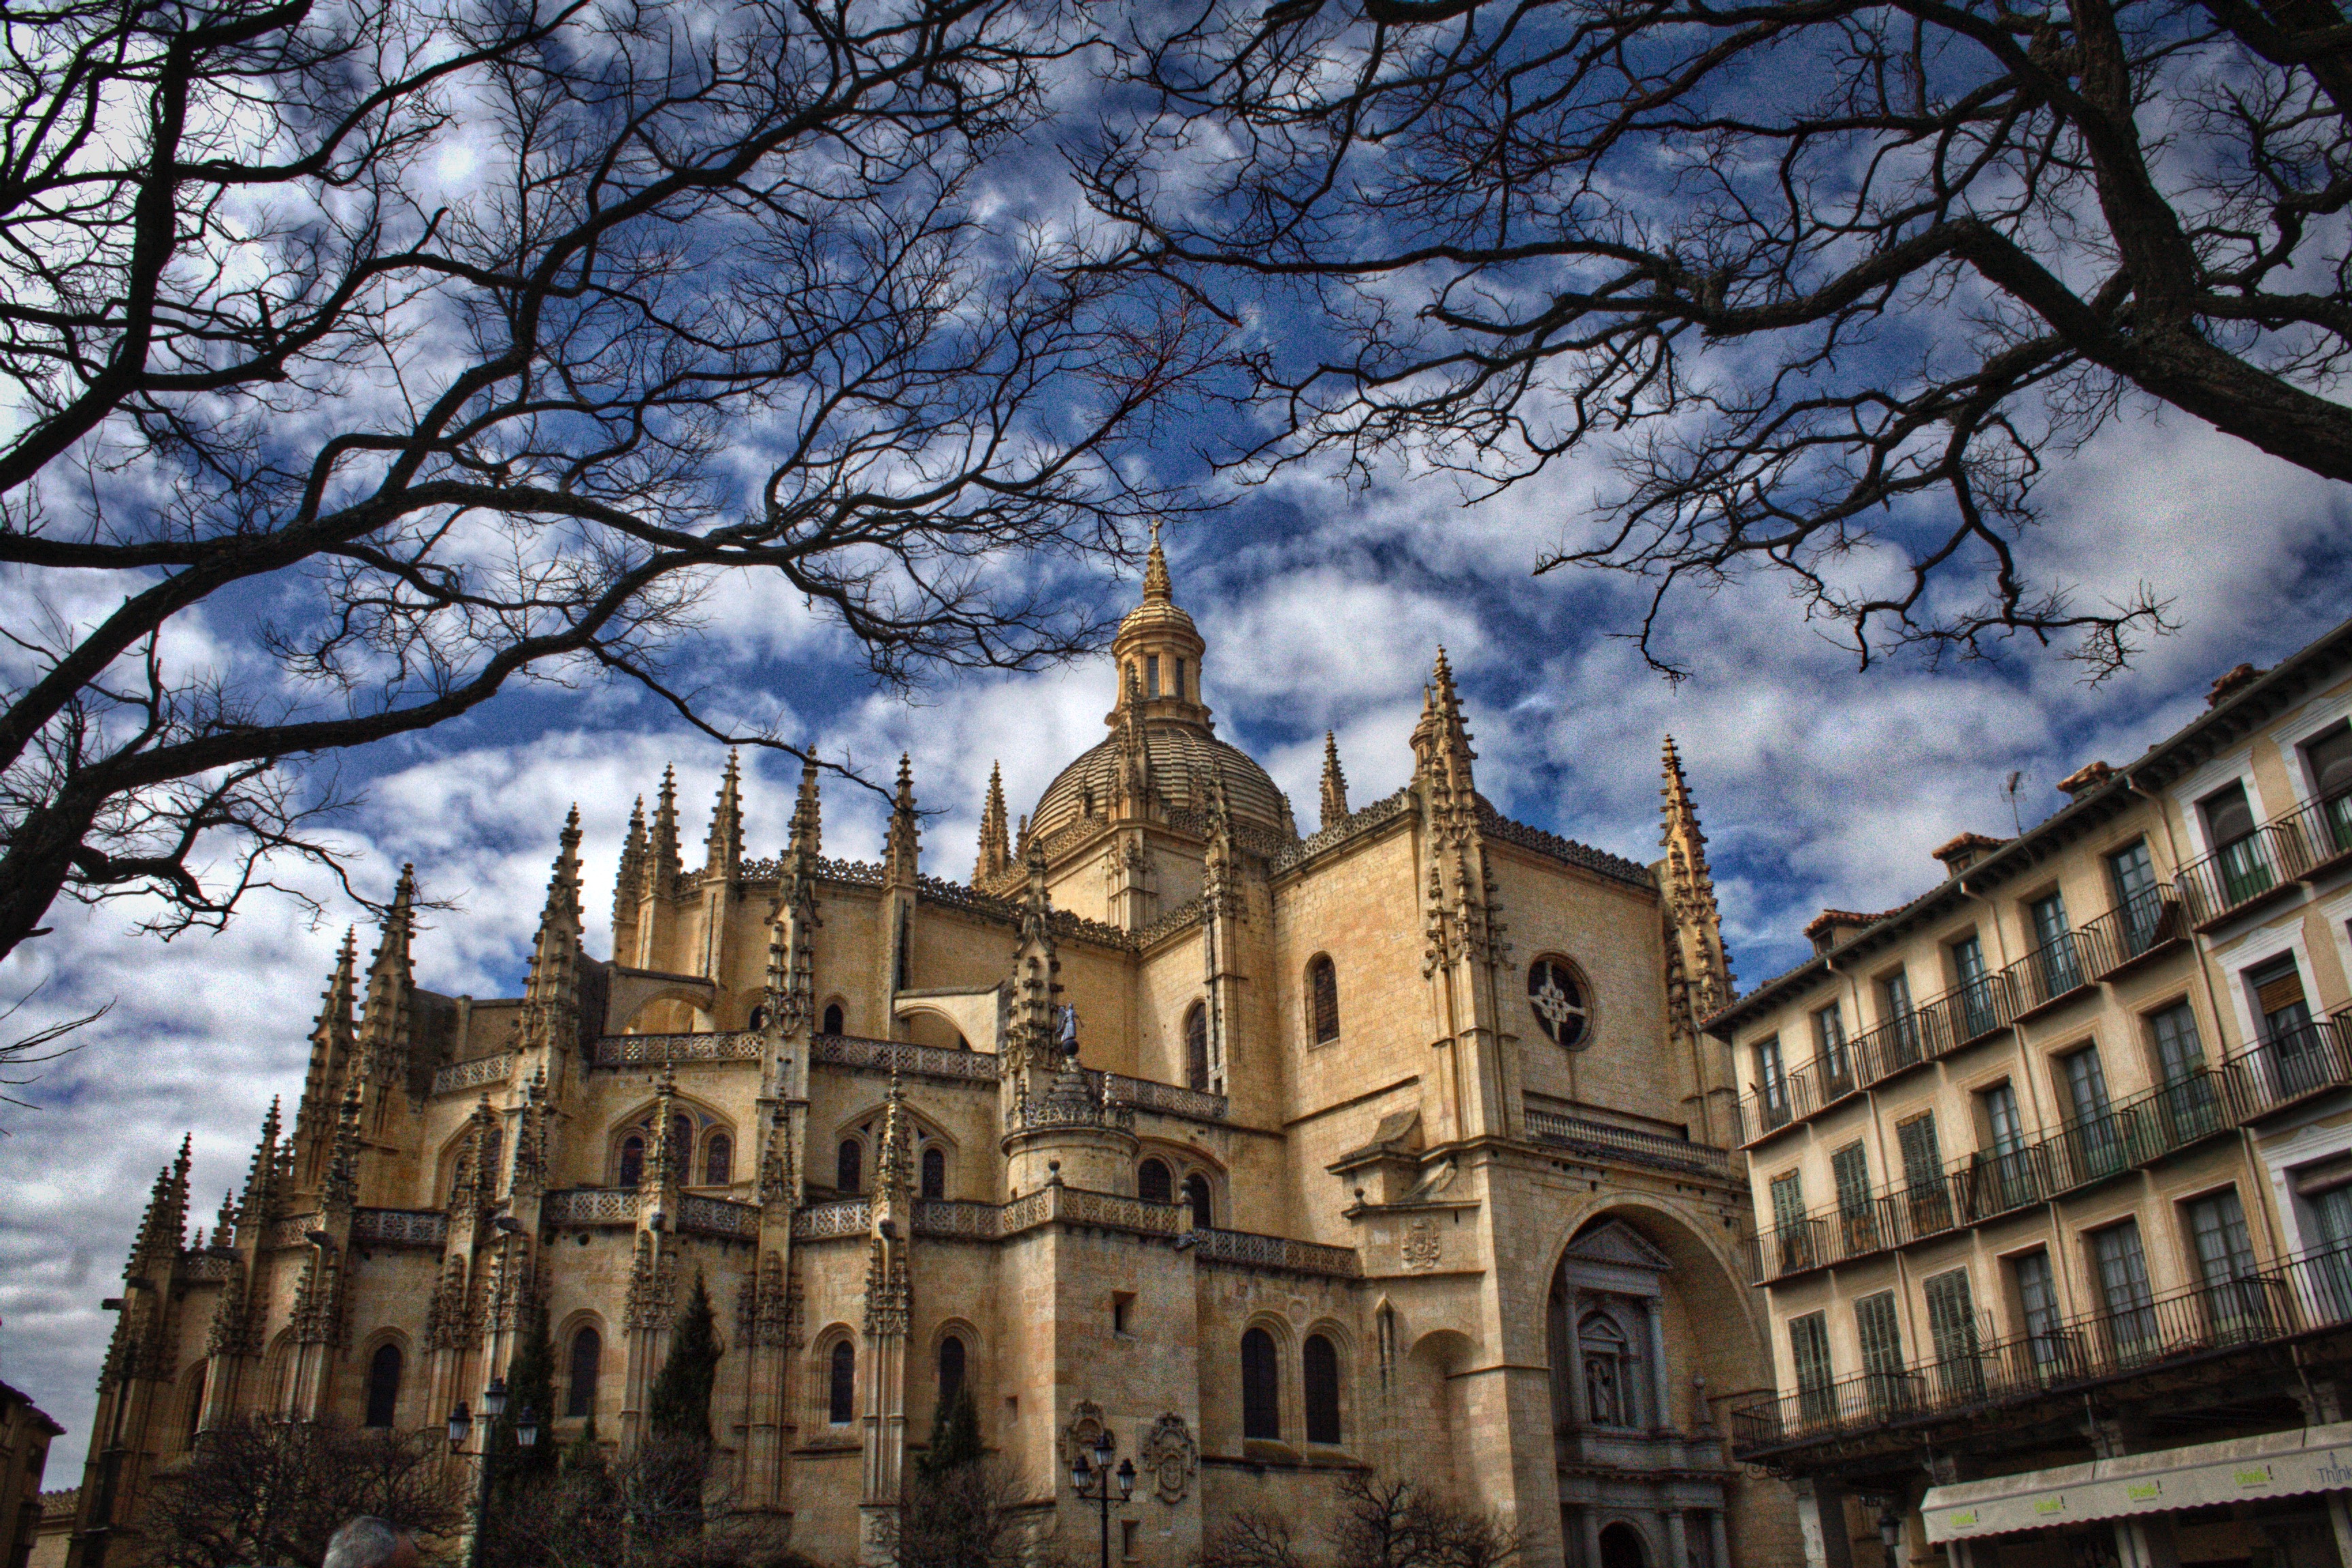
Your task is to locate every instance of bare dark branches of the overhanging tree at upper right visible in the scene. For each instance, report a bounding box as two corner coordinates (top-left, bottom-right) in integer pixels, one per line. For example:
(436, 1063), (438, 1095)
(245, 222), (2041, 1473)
(1089, 0), (2352, 672)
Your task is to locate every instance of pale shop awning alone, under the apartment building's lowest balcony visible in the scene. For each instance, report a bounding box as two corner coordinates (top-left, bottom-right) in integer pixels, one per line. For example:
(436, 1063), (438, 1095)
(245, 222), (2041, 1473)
(1919, 1422), (2352, 1544)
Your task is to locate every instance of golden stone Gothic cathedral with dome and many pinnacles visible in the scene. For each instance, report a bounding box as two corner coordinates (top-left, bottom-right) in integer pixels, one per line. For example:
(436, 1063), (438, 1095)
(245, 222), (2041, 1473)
(73, 543), (1799, 1568)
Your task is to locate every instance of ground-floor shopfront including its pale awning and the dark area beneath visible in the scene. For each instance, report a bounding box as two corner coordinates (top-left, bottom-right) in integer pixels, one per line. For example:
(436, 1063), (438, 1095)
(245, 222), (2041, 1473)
(1919, 1422), (2352, 1568)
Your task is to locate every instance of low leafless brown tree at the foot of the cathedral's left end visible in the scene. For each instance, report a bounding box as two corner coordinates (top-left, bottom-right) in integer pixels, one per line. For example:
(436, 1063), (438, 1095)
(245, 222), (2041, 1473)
(144, 1418), (466, 1568)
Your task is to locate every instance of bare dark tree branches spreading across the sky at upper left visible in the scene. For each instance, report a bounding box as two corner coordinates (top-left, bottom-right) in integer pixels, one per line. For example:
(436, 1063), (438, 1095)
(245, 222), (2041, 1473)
(0, 0), (1216, 957)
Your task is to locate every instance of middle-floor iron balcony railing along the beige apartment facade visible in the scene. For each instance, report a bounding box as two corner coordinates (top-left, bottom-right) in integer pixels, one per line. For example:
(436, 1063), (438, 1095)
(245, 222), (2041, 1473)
(1750, 1067), (2232, 1286)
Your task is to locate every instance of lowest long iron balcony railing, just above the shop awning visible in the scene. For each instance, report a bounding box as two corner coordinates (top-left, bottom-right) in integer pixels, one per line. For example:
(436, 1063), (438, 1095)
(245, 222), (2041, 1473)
(1731, 1246), (2352, 1460)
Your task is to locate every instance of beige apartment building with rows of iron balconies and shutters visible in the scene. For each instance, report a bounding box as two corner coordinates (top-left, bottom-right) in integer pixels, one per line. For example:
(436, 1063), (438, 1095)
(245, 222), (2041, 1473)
(1708, 623), (2352, 1568)
